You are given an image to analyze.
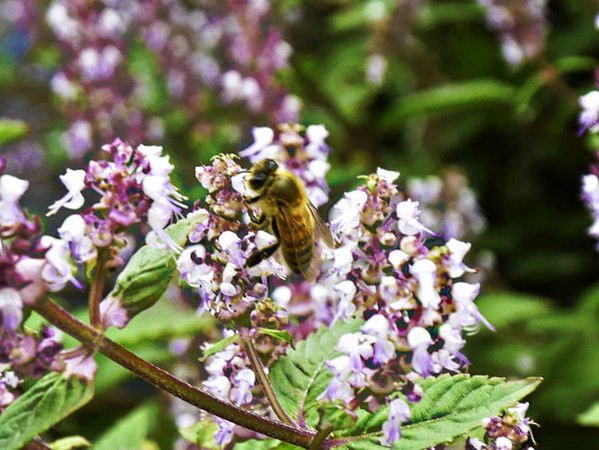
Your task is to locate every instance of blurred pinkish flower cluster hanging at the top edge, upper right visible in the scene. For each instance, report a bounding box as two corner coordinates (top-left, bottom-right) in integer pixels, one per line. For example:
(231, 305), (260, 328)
(478, 0), (547, 66)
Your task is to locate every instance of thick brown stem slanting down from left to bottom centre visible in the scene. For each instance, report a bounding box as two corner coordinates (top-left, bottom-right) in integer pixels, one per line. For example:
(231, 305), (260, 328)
(34, 300), (315, 448)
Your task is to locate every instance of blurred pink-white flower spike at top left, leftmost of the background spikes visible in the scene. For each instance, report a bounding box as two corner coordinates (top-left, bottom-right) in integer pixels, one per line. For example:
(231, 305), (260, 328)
(46, 0), (162, 158)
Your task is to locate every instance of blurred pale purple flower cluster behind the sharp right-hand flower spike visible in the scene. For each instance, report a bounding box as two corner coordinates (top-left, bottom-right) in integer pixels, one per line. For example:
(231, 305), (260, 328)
(406, 168), (486, 240)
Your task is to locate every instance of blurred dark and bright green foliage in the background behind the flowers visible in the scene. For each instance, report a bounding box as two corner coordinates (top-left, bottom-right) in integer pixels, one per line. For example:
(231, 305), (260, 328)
(0, 0), (599, 449)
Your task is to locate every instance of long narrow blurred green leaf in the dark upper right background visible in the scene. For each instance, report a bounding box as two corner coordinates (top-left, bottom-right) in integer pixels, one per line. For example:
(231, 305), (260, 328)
(381, 79), (514, 129)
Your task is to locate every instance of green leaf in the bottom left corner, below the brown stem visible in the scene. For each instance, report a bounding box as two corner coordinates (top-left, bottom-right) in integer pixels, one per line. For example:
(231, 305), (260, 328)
(0, 372), (93, 450)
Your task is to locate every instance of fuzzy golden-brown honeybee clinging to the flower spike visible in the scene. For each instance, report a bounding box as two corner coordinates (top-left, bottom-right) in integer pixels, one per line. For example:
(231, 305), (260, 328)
(245, 159), (334, 281)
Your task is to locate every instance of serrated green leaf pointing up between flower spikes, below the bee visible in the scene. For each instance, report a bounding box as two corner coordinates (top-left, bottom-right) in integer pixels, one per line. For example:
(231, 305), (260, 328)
(269, 319), (363, 426)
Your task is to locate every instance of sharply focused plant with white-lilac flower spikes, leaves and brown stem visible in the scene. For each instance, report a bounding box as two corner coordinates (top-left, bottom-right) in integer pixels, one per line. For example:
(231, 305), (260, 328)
(0, 124), (540, 449)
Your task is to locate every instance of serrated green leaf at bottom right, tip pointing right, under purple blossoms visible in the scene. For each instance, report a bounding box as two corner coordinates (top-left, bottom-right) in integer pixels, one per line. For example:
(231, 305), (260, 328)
(339, 374), (542, 450)
